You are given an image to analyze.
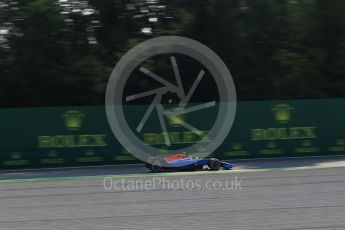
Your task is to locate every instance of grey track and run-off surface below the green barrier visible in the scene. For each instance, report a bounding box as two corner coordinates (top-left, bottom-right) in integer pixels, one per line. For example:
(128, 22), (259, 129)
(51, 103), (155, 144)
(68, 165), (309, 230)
(0, 157), (345, 230)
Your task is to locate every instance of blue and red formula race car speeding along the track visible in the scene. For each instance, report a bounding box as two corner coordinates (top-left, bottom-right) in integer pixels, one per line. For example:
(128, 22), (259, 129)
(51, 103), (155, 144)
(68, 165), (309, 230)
(145, 153), (233, 173)
